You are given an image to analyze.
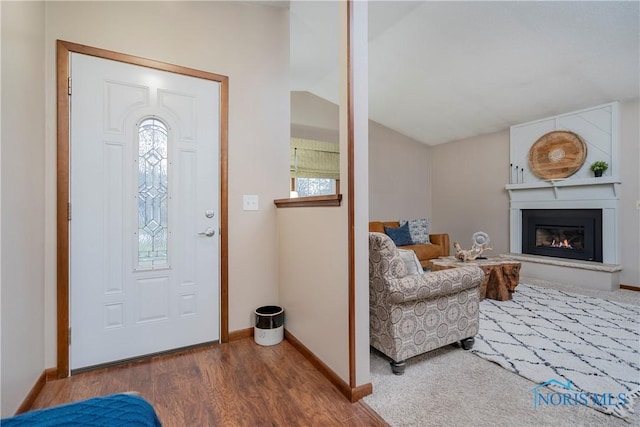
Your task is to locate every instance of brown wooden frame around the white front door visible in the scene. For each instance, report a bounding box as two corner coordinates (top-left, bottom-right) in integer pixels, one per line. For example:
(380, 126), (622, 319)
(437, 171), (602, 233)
(56, 40), (229, 378)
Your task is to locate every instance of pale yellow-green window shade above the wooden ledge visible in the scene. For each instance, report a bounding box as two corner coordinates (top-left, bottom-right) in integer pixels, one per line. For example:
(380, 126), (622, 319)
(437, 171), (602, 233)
(291, 138), (340, 179)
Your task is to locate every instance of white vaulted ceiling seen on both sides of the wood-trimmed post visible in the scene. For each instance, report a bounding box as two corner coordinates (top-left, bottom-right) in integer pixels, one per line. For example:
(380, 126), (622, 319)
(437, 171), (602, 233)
(289, 1), (640, 145)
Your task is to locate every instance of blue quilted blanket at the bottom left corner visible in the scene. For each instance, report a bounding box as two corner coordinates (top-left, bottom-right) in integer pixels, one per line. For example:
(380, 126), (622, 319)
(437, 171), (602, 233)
(0, 394), (162, 427)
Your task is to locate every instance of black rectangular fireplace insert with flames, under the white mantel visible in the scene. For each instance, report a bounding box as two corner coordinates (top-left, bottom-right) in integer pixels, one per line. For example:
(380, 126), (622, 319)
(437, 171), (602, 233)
(522, 209), (602, 262)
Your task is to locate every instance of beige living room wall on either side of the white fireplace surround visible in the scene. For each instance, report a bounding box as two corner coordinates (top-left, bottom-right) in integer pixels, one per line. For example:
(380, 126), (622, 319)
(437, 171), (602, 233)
(431, 99), (640, 286)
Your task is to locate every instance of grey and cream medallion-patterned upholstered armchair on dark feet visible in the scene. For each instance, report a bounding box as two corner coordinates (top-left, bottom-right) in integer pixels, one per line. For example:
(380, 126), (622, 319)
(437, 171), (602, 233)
(369, 233), (484, 375)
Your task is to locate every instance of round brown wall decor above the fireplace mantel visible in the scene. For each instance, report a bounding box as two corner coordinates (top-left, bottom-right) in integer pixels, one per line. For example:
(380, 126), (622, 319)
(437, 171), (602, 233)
(529, 130), (587, 179)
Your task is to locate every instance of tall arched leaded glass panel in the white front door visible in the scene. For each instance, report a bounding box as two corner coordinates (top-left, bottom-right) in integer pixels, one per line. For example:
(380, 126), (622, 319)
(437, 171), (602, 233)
(138, 118), (169, 268)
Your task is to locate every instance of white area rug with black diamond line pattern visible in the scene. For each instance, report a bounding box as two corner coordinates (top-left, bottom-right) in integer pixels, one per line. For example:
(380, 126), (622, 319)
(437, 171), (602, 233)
(471, 284), (640, 418)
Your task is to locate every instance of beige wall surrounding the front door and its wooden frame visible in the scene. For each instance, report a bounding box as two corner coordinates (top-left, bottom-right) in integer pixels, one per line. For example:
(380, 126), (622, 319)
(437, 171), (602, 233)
(45, 2), (289, 367)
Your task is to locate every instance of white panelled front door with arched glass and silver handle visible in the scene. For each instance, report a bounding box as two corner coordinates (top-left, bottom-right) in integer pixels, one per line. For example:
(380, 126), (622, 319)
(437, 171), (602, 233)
(70, 53), (220, 369)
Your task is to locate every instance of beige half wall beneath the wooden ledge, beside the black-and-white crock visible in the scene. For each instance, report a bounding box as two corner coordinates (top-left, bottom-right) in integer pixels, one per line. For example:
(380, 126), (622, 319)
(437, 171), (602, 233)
(277, 209), (349, 381)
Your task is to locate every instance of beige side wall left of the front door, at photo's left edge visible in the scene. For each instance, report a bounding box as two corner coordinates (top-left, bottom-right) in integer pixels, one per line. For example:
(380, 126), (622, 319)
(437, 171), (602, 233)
(0, 1), (45, 417)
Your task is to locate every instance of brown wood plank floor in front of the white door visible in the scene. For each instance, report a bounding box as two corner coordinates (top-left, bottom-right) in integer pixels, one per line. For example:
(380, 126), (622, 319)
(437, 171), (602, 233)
(32, 339), (387, 427)
